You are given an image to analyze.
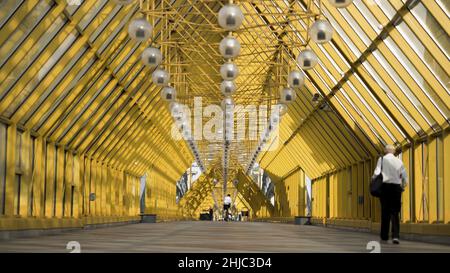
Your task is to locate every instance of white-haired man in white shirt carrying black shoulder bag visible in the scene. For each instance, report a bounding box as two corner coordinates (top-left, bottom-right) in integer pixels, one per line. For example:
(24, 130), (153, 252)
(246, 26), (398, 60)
(373, 145), (408, 244)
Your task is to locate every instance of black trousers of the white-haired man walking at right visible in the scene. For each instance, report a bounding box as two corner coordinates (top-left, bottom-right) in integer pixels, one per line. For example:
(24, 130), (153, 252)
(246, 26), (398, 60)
(380, 183), (403, 240)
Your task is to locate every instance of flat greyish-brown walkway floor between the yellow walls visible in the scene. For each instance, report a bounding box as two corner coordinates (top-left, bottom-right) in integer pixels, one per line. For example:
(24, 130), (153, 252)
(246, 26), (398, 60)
(0, 221), (450, 253)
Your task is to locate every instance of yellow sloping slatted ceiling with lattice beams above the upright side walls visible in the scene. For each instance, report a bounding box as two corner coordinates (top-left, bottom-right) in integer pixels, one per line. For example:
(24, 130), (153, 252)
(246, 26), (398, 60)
(0, 0), (450, 183)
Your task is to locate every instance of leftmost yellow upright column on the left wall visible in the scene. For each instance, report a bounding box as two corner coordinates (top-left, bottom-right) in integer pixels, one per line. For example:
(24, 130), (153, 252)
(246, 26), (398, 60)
(5, 124), (17, 216)
